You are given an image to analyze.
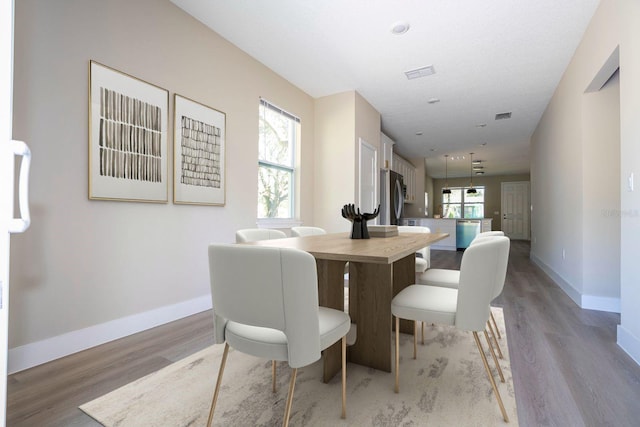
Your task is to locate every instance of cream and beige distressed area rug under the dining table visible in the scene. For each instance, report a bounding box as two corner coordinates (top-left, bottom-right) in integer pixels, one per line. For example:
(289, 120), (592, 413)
(80, 308), (518, 427)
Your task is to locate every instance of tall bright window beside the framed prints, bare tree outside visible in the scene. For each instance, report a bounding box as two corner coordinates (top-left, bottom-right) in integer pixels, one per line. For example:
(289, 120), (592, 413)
(258, 99), (300, 219)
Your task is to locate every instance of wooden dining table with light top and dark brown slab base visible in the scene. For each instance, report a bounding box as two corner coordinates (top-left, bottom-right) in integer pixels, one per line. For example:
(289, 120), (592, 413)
(250, 232), (449, 382)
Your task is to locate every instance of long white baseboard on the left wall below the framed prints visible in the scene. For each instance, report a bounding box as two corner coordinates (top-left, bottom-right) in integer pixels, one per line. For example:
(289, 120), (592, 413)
(8, 295), (211, 374)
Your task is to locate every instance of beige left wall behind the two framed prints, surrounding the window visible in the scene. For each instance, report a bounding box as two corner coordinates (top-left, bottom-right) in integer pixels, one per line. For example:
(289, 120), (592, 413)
(9, 0), (318, 364)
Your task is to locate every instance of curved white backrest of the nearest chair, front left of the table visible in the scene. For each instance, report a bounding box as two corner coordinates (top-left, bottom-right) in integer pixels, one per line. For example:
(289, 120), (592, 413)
(209, 244), (320, 368)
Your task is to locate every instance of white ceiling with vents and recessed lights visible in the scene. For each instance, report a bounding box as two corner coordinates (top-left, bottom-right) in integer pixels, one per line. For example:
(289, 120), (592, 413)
(171, 0), (599, 177)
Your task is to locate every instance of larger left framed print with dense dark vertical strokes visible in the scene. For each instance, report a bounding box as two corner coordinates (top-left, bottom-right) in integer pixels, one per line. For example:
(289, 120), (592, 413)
(89, 61), (169, 203)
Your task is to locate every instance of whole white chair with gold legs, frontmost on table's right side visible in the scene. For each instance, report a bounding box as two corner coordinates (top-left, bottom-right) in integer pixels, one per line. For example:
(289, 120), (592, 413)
(391, 237), (509, 422)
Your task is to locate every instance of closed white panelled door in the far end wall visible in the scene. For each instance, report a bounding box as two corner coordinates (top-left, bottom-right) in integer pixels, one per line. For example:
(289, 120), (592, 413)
(501, 181), (529, 240)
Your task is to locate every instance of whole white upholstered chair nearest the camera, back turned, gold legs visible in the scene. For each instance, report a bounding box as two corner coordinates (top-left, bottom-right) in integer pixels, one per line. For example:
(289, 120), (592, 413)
(208, 244), (351, 426)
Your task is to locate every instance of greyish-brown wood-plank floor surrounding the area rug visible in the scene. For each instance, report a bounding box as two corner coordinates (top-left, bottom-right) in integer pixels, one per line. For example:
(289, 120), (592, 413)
(7, 241), (640, 427)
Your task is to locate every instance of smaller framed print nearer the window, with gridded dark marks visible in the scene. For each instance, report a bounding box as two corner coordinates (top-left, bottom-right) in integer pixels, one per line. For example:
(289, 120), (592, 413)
(173, 94), (226, 206)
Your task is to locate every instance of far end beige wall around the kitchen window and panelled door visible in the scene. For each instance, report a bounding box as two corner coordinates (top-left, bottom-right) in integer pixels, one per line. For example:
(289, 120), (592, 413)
(430, 174), (529, 230)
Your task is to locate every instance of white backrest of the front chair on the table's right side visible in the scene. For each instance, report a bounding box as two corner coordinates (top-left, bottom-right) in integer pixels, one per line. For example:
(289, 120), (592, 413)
(456, 236), (510, 331)
